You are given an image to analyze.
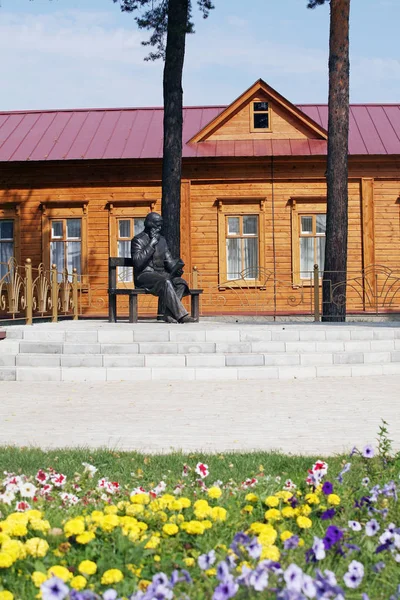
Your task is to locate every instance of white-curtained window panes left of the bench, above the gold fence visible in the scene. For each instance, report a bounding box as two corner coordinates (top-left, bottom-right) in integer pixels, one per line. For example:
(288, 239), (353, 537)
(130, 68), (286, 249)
(50, 218), (82, 281)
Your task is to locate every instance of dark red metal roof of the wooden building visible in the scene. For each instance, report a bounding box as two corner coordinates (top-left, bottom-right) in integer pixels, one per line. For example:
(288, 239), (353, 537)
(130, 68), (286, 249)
(0, 104), (400, 162)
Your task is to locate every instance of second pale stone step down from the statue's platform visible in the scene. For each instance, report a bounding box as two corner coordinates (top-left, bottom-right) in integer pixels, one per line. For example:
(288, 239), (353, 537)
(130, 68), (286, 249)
(14, 339), (400, 355)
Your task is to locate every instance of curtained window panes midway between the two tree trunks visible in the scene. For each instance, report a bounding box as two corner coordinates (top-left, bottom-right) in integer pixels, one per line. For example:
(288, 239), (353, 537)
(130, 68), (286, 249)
(226, 215), (259, 280)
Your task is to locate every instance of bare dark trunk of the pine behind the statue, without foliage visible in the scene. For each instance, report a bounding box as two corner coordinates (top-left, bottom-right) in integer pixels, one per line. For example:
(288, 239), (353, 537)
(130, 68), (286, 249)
(161, 0), (189, 257)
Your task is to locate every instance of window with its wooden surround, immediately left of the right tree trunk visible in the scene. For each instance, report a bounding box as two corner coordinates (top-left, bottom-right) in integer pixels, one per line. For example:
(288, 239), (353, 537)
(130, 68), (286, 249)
(291, 196), (326, 285)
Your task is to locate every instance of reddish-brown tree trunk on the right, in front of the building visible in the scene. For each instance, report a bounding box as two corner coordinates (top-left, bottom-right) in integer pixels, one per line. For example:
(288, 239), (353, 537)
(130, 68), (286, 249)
(322, 0), (350, 321)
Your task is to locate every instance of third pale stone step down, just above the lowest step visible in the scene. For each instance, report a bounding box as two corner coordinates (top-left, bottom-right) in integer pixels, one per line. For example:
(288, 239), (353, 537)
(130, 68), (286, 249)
(7, 350), (400, 368)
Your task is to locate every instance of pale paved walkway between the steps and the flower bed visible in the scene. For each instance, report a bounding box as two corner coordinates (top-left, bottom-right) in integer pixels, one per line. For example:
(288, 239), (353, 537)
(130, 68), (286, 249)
(0, 376), (400, 455)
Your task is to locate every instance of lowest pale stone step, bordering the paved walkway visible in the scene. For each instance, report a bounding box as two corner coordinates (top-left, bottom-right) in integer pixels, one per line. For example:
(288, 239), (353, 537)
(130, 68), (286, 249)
(0, 363), (400, 381)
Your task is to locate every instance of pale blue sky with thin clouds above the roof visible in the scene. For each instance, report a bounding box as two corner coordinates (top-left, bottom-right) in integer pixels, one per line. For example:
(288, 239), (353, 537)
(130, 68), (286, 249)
(0, 0), (400, 110)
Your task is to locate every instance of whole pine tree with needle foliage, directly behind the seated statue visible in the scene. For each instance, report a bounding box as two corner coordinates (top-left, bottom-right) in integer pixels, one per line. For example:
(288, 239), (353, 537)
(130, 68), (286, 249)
(113, 0), (214, 256)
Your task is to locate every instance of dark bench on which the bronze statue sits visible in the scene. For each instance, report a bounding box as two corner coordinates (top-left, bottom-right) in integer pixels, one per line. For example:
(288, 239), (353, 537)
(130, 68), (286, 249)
(108, 256), (203, 323)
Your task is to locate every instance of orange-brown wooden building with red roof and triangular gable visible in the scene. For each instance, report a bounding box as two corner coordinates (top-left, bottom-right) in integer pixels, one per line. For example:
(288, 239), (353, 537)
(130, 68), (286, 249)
(0, 80), (400, 316)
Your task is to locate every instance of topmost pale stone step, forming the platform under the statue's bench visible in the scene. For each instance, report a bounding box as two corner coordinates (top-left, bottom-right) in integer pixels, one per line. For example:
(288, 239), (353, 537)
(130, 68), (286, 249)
(1, 321), (400, 342)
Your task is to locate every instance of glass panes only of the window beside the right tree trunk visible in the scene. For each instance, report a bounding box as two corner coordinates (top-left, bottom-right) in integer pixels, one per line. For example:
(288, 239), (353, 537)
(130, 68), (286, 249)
(299, 214), (326, 279)
